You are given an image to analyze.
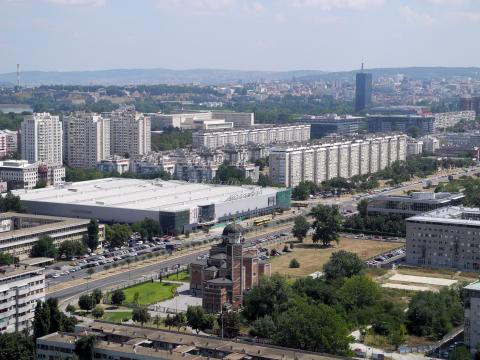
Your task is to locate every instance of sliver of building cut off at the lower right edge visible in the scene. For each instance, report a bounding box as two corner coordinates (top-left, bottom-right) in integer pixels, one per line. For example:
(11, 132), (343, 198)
(463, 281), (480, 355)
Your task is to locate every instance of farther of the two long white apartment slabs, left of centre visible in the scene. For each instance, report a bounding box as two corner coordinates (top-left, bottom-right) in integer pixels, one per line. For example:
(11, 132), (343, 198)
(192, 125), (310, 149)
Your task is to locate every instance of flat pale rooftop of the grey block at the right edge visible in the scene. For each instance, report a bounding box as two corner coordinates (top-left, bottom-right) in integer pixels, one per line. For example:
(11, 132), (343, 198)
(407, 206), (480, 227)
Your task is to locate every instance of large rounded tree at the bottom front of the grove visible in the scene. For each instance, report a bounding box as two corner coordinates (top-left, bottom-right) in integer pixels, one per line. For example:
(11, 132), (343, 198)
(273, 304), (351, 356)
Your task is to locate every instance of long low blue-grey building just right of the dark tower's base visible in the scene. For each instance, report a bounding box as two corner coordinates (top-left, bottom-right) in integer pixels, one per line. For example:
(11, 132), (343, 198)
(367, 115), (435, 135)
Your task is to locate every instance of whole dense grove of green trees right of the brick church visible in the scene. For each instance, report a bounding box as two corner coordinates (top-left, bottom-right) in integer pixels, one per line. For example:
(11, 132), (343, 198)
(242, 251), (463, 356)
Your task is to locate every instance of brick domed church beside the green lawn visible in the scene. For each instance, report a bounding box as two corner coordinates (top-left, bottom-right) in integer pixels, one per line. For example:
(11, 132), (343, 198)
(190, 224), (271, 313)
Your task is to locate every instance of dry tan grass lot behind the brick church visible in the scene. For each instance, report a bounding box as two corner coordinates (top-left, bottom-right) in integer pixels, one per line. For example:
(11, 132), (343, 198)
(271, 238), (402, 277)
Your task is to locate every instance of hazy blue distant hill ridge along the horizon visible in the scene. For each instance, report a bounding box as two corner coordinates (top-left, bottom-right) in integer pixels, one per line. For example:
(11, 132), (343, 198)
(0, 67), (480, 86)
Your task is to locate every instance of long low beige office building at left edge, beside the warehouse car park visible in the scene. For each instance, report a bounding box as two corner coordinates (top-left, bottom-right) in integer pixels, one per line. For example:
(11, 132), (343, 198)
(0, 212), (104, 260)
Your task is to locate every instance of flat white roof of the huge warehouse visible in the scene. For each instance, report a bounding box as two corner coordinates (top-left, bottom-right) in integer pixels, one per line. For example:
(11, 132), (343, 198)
(13, 178), (278, 211)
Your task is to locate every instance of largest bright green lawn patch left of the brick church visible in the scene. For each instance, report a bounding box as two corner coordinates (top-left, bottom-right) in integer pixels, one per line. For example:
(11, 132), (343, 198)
(123, 282), (178, 305)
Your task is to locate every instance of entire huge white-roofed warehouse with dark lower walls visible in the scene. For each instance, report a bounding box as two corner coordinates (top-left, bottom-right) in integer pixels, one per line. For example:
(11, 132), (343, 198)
(15, 178), (291, 233)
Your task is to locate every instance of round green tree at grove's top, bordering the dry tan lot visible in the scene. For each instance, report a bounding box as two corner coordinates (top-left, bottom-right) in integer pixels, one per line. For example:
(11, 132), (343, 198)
(323, 250), (364, 281)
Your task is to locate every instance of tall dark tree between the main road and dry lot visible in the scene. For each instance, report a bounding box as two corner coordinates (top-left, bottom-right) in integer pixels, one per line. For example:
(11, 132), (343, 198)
(311, 205), (344, 246)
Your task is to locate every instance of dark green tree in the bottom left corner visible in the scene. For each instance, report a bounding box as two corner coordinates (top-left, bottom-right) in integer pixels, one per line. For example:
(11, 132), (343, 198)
(0, 332), (35, 360)
